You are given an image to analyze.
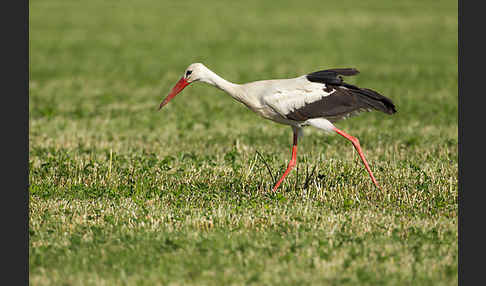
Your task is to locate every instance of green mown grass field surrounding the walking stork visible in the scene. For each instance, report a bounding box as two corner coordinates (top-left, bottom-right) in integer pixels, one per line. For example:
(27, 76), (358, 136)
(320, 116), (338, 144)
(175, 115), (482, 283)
(29, 0), (458, 285)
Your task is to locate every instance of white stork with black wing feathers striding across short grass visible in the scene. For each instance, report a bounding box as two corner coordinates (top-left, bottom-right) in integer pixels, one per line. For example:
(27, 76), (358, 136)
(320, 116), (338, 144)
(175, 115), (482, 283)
(159, 63), (396, 192)
